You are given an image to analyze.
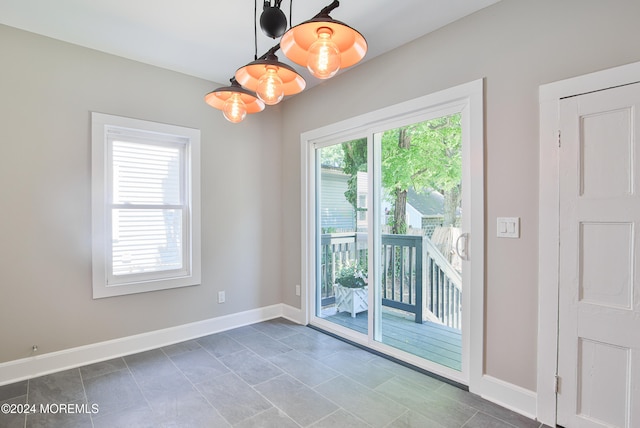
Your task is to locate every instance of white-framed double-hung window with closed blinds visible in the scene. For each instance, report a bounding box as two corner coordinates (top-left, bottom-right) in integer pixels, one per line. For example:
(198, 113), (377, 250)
(92, 113), (200, 298)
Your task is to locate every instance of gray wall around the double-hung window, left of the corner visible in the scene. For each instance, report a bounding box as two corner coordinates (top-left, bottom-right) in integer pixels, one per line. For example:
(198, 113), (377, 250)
(0, 26), (282, 363)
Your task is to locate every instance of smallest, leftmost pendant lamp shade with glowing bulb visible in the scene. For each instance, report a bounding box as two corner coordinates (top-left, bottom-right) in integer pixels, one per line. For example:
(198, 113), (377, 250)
(204, 79), (264, 123)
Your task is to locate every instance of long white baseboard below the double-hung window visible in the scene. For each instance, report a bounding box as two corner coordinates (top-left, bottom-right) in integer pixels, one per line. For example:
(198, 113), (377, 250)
(0, 304), (300, 386)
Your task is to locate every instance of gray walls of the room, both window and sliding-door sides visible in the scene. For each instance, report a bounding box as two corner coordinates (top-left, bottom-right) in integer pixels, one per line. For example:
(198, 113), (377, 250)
(0, 0), (640, 398)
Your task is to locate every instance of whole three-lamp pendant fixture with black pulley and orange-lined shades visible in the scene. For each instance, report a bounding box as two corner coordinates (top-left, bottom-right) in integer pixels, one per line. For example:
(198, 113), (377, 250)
(204, 0), (367, 123)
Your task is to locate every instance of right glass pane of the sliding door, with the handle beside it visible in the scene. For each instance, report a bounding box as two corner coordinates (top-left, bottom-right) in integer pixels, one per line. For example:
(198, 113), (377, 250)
(373, 114), (462, 371)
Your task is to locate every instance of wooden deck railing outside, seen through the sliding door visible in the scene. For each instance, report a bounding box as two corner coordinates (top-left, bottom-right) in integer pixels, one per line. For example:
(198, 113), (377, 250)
(319, 233), (462, 329)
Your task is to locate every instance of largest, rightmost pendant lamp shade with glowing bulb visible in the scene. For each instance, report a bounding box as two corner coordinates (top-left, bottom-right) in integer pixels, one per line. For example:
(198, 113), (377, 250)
(280, 0), (367, 79)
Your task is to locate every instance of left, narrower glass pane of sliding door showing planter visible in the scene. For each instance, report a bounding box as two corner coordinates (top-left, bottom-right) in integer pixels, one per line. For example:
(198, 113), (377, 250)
(315, 138), (369, 335)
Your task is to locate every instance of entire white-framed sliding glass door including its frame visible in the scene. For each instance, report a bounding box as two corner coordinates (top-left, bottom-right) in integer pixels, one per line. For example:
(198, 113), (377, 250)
(303, 81), (484, 383)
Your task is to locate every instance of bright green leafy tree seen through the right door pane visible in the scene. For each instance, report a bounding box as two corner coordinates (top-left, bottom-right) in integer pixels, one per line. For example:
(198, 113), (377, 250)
(382, 114), (462, 234)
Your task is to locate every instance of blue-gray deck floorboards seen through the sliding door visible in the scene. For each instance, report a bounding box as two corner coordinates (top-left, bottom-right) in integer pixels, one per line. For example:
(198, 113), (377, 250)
(325, 310), (462, 370)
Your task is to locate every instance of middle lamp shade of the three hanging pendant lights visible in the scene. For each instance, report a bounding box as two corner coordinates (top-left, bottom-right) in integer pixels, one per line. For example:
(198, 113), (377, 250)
(236, 48), (306, 105)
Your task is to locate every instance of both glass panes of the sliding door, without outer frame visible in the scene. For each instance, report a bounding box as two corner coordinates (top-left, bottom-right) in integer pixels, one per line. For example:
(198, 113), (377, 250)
(315, 113), (463, 371)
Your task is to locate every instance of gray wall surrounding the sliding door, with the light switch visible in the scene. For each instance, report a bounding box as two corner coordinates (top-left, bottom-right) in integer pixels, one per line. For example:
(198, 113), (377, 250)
(283, 0), (640, 391)
